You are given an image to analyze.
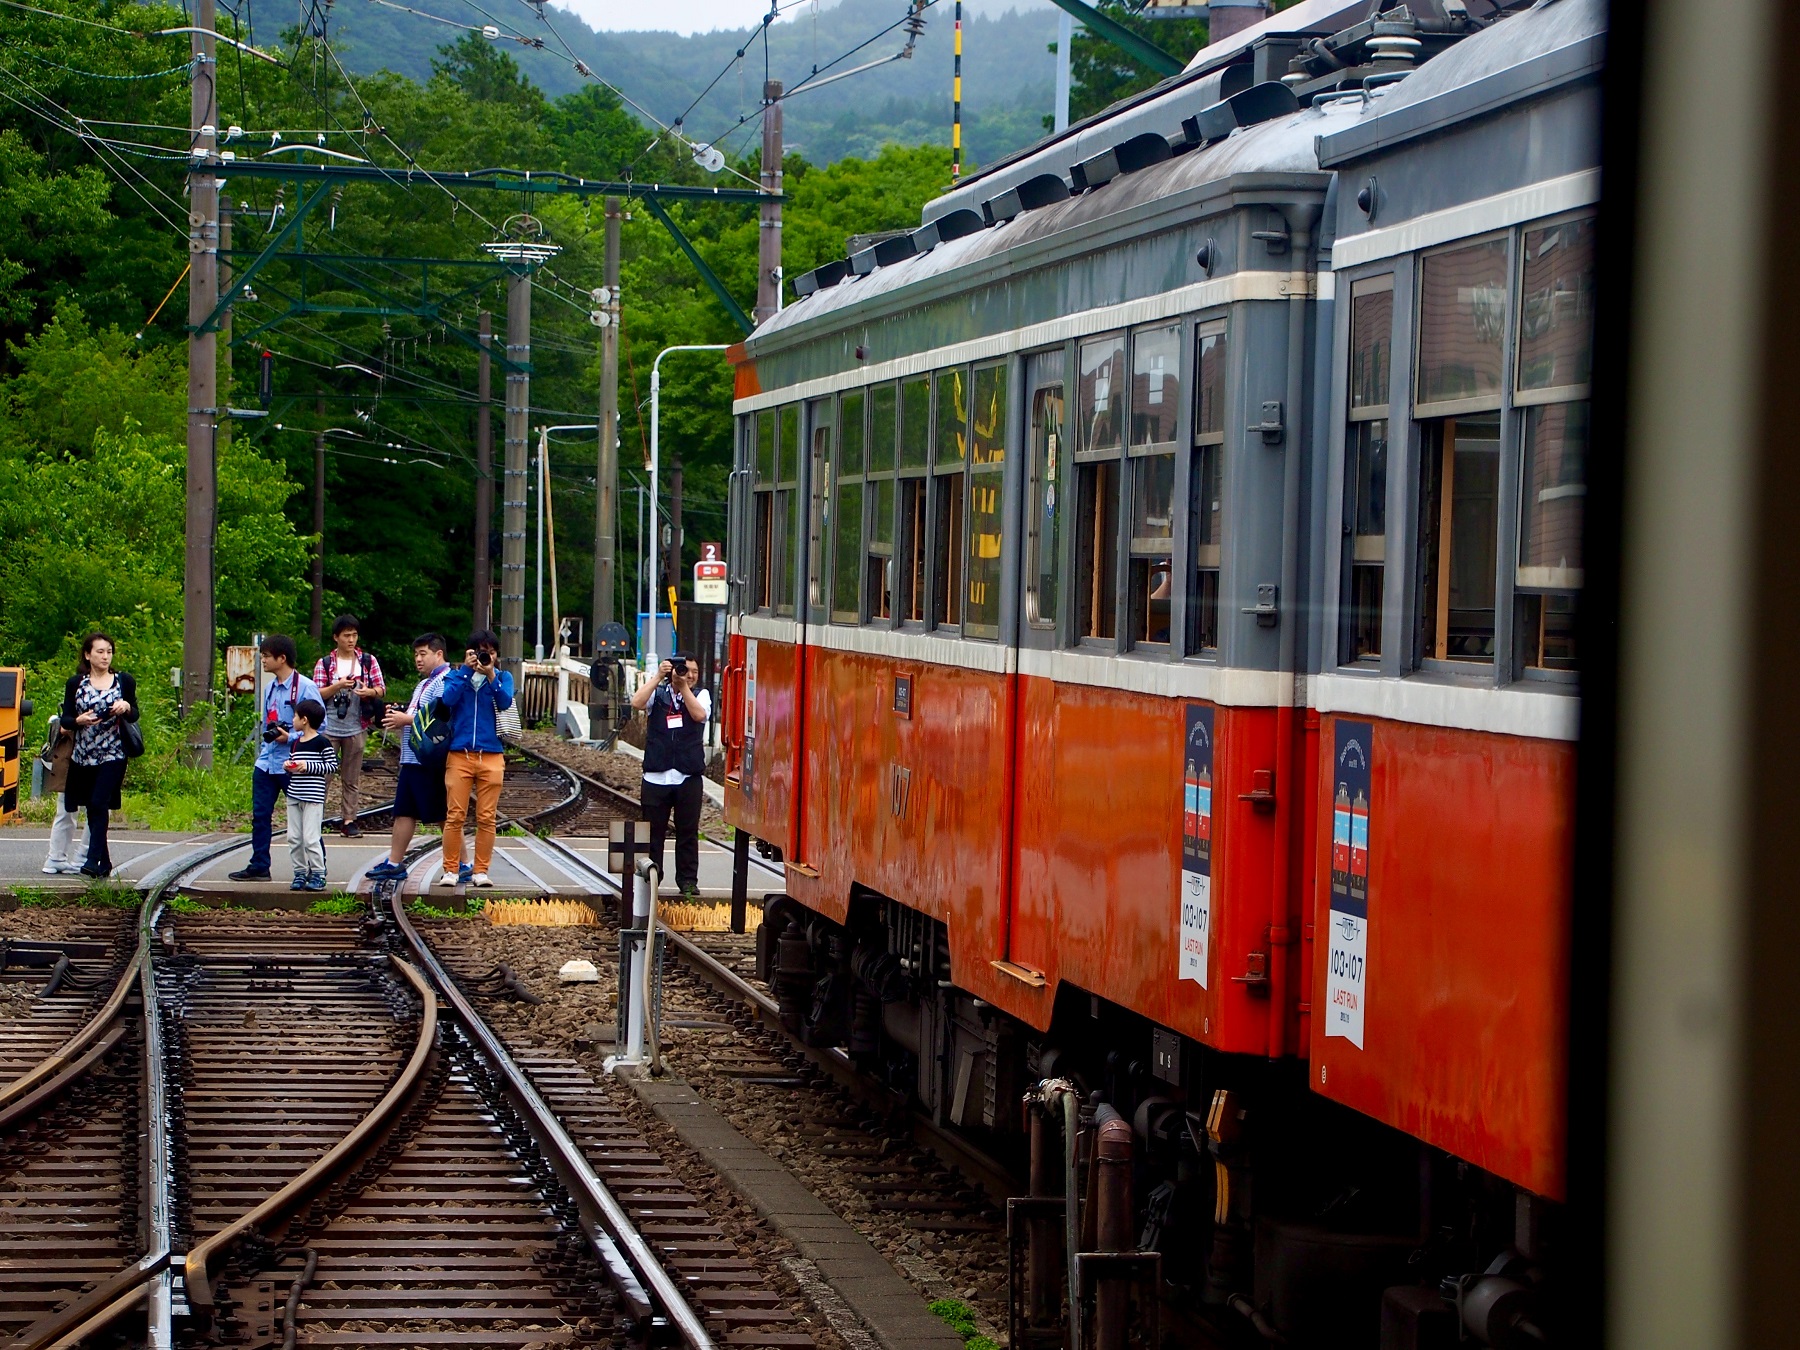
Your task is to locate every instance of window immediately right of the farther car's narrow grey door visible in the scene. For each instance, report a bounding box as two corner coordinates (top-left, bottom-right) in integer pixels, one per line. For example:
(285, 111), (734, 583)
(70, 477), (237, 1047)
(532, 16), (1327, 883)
(1075, 333), (1125, 637)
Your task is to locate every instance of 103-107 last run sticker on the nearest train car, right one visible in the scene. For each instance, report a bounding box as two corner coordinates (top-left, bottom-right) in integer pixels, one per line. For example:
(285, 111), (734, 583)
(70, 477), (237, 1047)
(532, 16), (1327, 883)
(1325, 718), (1375, 1049)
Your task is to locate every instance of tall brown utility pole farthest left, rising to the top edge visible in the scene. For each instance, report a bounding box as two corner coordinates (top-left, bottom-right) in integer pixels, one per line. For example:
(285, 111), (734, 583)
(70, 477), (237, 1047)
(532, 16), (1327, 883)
(182, 0), (220, 769)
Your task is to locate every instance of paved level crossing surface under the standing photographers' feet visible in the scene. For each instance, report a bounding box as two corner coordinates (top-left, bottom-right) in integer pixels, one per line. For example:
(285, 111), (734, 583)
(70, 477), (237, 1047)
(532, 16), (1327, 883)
(0, 826), (781, 909)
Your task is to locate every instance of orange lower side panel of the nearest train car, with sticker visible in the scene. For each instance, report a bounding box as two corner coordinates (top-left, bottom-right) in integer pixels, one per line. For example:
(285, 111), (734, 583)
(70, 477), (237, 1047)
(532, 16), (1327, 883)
(1310, 716), (1575, 1199)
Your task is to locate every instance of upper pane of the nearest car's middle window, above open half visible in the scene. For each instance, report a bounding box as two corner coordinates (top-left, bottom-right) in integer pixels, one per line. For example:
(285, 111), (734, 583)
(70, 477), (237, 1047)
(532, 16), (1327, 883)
(1417, 238), (1508, 412)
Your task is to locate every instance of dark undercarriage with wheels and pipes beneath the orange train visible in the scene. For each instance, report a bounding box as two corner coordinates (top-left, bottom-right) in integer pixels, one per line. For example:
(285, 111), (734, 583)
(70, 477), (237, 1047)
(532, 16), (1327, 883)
(756, 887), (1559, 1350)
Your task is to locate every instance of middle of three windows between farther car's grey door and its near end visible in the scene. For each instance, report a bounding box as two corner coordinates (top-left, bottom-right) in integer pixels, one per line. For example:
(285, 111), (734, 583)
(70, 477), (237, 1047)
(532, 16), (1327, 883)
(1125, 324), (1181, 646)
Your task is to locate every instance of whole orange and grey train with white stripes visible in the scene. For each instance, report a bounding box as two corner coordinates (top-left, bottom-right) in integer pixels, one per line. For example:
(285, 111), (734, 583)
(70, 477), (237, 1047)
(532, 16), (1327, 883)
(724, 0), (1606, 1350)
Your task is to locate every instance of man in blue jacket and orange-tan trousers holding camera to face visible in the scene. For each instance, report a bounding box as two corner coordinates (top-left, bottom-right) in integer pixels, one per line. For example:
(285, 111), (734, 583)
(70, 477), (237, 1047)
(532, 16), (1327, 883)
(437, 628), (513, 886)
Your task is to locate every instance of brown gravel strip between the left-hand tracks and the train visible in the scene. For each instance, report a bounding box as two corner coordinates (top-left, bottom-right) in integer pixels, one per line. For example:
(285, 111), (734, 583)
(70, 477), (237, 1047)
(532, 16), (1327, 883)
(430, 922), (1006, 1345)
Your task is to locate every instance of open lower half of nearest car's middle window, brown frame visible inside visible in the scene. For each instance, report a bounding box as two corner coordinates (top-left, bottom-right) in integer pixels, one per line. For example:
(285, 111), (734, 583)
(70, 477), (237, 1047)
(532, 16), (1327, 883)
(1418, 412), (1499, 661)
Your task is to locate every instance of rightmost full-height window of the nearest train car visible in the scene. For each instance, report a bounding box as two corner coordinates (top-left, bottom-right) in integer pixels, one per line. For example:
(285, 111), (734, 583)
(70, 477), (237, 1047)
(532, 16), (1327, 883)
(1514, 216), (1595, 671)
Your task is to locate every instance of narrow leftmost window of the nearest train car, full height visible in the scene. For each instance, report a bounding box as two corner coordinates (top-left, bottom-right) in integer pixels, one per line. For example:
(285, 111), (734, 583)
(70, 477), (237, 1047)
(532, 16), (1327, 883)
(1341, 272), (1393, 664)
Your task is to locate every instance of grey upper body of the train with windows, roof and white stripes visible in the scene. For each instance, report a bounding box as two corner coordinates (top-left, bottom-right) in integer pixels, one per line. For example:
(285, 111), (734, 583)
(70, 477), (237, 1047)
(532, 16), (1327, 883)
(733, 0), (1606, 738)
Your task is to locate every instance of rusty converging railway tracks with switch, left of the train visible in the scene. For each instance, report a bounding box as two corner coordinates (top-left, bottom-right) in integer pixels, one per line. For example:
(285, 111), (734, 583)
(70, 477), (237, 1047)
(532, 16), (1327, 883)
(0, 770), (814, 1350)
